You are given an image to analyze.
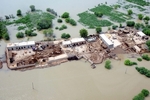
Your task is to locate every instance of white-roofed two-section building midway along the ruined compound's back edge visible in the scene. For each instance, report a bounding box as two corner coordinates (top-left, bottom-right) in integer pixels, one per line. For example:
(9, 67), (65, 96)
(62, 38), (85, 47)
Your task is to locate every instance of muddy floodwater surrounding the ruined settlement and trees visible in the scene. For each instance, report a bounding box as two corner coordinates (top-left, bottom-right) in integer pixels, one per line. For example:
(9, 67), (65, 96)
(0, 0), (150, 100)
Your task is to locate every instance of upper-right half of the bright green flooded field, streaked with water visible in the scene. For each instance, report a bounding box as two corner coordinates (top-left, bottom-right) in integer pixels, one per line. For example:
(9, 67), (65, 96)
(90, 4), (130, 23)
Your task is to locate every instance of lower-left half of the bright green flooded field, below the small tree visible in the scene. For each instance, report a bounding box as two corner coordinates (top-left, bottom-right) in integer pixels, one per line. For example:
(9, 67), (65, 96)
(78, 12), (112, 28)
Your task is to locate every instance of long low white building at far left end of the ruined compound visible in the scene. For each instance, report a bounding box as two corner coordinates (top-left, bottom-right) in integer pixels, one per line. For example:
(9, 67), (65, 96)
(7, 41), (35, 50)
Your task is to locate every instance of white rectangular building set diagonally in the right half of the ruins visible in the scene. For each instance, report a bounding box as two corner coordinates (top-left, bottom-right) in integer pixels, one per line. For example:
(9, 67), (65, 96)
(99, 34), (114, 48)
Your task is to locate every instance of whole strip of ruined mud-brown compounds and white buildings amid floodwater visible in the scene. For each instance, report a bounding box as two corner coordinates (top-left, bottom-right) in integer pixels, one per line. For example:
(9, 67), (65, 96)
(6, 28), (149, 69)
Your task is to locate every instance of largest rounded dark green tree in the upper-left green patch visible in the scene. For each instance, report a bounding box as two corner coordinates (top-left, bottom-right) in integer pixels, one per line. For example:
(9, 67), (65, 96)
(37, 19), (52, 30)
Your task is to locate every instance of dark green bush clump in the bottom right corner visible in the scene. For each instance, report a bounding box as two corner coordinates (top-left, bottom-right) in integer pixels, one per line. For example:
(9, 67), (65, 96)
(132, 89), (149, 100)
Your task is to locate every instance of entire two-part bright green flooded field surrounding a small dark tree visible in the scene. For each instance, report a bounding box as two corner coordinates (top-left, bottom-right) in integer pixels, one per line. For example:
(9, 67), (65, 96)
(78, 4), (131, 28)
